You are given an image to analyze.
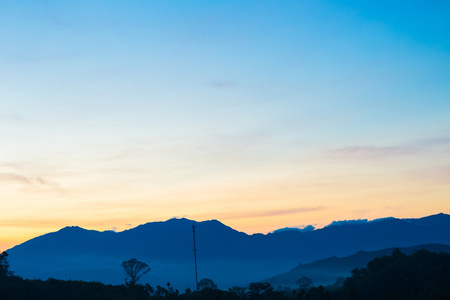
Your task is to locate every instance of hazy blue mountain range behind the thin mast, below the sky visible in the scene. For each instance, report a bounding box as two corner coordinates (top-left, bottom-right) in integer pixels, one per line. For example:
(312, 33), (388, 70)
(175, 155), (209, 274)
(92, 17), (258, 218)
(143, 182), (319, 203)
(8, 214), (450, 289)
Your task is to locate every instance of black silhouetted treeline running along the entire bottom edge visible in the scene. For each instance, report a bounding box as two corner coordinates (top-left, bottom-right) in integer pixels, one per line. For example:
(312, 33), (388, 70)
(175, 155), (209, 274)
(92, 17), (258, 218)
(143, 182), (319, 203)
(0, 249), (450, 300)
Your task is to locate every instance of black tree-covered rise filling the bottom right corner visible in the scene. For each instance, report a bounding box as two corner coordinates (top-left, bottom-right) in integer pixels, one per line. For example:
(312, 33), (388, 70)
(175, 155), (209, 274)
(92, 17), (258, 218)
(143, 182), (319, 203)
(333, 249), (450, 300)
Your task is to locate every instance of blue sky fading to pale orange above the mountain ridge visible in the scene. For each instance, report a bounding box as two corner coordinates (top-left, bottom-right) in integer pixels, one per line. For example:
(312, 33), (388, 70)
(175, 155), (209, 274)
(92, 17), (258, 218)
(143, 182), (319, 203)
(0, 0), (450, 250)
